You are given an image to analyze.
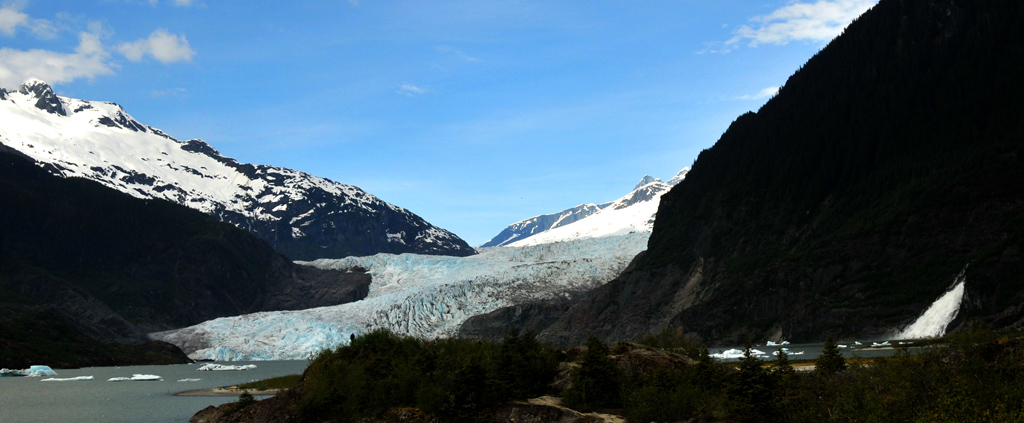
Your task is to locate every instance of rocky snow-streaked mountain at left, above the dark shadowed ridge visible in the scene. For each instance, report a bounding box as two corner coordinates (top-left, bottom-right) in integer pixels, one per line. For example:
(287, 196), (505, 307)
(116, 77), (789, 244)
(0, 80), (474, 259)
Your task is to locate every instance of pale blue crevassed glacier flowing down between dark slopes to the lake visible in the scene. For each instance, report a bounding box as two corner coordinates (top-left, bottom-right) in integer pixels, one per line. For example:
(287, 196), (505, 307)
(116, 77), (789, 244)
(150, 234), (649, 361)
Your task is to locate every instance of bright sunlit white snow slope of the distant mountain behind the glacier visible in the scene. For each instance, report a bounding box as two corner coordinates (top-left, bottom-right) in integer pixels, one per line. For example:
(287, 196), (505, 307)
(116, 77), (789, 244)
(503, 168), (689, 247)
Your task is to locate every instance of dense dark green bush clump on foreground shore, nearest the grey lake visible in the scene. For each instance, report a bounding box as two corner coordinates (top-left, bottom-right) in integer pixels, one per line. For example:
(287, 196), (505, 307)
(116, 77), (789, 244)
(297, 330), (558, 422)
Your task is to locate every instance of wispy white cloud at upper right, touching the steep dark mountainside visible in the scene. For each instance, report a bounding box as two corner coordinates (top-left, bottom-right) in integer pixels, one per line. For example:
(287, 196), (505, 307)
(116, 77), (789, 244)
(705, 0), (878, 52)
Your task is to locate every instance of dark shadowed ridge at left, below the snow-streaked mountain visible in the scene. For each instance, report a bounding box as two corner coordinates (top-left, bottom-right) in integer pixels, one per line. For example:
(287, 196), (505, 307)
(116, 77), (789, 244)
(0, 147), (370, 356)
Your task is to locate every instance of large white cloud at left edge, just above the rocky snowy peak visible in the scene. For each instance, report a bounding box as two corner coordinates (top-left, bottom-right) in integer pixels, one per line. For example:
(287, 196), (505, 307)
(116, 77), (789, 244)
(0, 28), (114, 87)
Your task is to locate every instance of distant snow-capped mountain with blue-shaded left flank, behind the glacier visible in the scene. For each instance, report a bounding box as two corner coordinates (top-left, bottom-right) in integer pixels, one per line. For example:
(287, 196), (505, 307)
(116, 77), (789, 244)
(483, 168), (689, 247)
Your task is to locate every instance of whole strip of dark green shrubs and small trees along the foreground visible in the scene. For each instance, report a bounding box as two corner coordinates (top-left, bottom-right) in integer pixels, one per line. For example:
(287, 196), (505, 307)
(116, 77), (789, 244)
(266, 330), (1024, 423)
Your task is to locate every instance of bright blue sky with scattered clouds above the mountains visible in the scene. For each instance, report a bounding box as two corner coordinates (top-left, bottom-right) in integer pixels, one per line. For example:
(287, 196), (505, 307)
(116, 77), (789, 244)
(0, 0), (877, 245)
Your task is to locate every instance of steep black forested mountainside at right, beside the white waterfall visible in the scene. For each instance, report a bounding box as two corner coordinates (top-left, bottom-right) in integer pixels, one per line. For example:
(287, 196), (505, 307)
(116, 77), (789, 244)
(541, 0), (1024, 344)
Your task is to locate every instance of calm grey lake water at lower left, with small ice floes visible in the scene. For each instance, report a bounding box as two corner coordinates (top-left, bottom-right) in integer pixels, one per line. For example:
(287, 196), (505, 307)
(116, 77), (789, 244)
(0, 361), (308, 423)
